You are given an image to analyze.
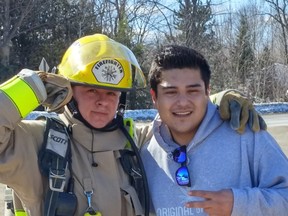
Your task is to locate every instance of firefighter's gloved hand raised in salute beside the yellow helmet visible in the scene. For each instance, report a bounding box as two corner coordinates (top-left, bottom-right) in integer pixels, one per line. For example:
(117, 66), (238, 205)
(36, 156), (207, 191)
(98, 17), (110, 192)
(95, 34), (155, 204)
(37, 71), (72, 113)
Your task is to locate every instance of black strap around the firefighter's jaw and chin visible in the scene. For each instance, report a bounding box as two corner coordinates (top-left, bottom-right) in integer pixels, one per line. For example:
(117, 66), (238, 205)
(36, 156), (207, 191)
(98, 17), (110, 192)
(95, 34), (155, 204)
(67, 92), (126, 132)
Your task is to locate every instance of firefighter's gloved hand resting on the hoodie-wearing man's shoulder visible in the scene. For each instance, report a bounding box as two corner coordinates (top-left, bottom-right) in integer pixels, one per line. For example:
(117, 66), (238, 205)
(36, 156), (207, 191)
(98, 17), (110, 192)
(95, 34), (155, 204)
(219, 91), (267, 133)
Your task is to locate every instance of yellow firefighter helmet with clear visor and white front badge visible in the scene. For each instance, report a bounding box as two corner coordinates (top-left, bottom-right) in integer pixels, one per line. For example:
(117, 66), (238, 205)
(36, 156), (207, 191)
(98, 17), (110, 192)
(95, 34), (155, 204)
(58, 34), (146, 91)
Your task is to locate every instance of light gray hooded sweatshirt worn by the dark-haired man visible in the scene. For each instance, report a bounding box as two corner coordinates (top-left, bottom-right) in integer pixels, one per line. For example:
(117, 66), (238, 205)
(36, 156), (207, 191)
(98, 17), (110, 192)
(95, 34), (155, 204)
(141, 102), (288, 216)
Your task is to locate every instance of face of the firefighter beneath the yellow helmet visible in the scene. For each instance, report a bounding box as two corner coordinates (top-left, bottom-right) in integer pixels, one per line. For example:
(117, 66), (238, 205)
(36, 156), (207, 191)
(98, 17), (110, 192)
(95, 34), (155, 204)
(73, 86), (121, 128)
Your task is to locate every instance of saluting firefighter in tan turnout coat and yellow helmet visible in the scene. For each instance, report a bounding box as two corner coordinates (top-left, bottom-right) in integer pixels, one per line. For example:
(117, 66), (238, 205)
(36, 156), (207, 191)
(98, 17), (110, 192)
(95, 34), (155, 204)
(0, 34), (266, 216)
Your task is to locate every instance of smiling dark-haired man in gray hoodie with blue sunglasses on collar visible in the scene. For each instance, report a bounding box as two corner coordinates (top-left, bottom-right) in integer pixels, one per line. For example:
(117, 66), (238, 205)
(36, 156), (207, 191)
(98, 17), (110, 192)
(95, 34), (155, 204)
(140, 45), (288, 216)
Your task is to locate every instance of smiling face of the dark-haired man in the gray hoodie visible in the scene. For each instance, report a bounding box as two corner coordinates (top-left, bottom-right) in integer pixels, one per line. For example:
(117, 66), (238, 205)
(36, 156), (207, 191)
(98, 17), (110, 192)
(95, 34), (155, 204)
(151, 68), (209, 145)
